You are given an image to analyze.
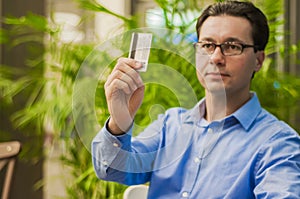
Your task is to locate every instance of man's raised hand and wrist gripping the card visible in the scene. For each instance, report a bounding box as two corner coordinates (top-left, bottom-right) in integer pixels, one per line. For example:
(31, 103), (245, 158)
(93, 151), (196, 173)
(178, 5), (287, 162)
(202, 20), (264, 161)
(104, 58), (144, 135)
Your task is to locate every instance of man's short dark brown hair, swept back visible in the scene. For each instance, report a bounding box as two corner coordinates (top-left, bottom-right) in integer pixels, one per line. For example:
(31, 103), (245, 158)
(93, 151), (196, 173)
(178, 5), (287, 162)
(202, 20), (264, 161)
(196, 1), (269, 50)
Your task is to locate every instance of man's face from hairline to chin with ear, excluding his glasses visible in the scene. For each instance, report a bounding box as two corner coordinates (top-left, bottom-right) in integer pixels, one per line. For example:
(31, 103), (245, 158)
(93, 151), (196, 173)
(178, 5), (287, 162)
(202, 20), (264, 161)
(196, 15), (264, 95)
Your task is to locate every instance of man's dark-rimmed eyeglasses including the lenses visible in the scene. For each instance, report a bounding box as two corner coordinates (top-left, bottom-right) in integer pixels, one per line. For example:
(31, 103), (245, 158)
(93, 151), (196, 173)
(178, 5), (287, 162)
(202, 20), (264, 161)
(194, 41), (257, 56)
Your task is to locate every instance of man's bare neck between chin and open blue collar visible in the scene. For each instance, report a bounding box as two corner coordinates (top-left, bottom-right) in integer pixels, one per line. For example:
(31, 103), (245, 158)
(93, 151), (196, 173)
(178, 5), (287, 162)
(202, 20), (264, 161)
(205, 92), (251, 122)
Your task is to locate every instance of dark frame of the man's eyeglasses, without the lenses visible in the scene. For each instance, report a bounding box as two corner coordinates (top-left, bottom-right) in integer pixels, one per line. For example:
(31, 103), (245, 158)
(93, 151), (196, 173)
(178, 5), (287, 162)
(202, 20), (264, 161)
(193, 41), (258, 56)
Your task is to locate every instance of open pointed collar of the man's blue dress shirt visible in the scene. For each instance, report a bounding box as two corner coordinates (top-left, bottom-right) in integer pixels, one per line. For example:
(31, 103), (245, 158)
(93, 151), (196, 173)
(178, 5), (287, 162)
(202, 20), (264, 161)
(184, 92), (261, 131)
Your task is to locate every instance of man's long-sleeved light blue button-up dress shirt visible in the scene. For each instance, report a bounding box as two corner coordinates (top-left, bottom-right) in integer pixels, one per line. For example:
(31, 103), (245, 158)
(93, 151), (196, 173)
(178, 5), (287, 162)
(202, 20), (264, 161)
(92, 93), (300, 199)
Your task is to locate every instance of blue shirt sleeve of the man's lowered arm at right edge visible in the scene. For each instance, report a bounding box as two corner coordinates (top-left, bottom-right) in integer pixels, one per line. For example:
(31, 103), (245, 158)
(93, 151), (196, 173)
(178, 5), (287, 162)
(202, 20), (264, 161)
(254, 126), (300, 199)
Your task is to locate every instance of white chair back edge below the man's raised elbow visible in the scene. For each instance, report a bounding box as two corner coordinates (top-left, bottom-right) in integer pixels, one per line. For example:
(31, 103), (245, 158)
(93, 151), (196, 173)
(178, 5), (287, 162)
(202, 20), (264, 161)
(123, 185), (149, 199)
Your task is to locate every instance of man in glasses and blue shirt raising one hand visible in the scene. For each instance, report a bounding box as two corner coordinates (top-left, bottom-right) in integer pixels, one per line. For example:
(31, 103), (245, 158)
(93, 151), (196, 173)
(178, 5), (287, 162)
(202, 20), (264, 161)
(92, 1), (300, 199)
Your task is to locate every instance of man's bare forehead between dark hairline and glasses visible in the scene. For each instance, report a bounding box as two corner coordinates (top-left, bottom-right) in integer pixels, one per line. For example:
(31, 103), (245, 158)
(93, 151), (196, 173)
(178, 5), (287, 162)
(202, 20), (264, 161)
(199, 15), (253, 42)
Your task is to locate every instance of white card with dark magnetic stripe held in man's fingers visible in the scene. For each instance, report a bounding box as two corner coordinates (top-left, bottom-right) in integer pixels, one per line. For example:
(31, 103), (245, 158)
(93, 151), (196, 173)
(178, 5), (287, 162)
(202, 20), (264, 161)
(129, 32), (152, 72)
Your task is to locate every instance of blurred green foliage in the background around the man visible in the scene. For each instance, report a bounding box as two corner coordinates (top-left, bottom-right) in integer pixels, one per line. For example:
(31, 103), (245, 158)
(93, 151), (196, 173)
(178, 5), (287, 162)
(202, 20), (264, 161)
(0, 0), (300, 199)
